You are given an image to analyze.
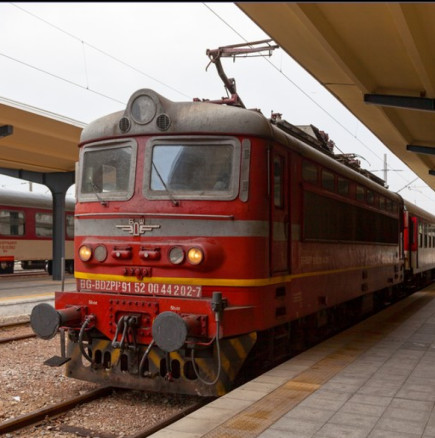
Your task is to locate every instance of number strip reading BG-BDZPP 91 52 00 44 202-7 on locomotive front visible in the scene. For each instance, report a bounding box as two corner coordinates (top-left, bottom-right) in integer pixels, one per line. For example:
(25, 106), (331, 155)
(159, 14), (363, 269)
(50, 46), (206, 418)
(80, 280), (202, 298)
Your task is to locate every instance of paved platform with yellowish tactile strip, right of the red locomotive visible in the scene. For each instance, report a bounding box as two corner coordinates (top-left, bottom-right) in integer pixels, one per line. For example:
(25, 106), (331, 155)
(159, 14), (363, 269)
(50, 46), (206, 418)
(150, 285), (435, 438)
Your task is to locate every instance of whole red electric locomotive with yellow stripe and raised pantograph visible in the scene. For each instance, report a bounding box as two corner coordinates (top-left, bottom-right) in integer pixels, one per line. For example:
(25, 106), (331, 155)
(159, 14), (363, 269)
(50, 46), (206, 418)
(31, 41), (435, 396)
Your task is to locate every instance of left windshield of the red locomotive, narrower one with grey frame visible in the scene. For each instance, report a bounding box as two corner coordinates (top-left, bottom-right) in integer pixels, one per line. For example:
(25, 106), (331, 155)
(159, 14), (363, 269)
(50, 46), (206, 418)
(79, 140), (136, 202)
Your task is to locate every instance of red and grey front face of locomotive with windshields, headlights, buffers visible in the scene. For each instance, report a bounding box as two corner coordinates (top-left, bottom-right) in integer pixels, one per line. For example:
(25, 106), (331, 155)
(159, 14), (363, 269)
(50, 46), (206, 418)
(32, 90), (268, 395)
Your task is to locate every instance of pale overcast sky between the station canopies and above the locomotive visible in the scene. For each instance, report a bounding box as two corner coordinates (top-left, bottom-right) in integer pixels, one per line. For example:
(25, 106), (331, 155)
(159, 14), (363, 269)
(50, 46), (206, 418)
(0, 2), (435, 214)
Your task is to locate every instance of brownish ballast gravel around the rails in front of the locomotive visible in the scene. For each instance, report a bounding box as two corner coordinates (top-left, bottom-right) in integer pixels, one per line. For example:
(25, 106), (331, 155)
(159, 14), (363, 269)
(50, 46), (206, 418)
(0, 320), (201, 438)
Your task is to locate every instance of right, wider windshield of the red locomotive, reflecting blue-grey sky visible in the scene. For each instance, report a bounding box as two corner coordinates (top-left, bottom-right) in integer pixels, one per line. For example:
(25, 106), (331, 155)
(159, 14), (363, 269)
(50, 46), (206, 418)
(144, 141), (240, 200)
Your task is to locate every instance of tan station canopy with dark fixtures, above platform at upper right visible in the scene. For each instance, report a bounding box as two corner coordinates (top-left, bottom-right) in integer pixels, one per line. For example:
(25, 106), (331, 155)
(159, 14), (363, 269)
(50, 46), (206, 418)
(240, 2), (435, 189)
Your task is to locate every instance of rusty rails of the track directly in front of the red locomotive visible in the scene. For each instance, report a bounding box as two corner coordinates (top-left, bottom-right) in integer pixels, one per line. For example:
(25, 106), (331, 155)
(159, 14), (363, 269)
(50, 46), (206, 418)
(0, 387), (210, 438)
